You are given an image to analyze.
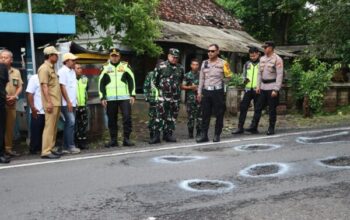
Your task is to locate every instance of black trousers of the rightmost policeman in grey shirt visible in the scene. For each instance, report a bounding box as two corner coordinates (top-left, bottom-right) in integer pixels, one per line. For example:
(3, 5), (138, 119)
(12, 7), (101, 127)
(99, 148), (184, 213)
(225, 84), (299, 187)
(252, 90), (279, 128)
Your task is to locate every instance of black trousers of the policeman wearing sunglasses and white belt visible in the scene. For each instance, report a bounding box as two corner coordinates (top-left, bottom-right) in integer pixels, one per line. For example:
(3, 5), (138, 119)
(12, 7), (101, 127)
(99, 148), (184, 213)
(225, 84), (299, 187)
(201, 89), (225, 135)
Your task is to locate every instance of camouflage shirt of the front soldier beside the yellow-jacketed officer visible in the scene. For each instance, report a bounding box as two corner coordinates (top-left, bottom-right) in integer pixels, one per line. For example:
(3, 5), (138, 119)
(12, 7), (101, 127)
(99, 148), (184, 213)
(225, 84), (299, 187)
(154, 61), (184, 100)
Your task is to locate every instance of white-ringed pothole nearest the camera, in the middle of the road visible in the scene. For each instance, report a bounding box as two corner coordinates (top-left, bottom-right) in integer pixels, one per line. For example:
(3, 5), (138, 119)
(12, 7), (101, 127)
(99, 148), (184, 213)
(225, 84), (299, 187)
(180, 179), (234, 193)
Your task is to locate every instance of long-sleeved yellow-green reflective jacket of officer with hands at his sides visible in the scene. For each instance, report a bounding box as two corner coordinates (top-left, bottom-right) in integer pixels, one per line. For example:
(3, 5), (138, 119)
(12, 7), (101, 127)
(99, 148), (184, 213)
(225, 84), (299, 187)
(99, 62), (136, 101)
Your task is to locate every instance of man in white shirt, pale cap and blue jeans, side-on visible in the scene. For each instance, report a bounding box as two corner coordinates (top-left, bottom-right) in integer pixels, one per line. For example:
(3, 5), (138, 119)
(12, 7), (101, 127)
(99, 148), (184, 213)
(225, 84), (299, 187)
(58, 53), (80, 154)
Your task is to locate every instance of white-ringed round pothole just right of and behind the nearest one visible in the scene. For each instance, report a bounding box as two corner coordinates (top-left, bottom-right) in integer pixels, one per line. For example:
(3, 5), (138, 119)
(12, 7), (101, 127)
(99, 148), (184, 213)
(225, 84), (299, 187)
(239, 163), (288, 177)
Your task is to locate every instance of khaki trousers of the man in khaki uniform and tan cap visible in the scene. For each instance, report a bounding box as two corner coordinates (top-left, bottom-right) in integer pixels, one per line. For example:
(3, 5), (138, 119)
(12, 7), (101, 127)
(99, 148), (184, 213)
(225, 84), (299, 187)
(41, 106), (61, 156)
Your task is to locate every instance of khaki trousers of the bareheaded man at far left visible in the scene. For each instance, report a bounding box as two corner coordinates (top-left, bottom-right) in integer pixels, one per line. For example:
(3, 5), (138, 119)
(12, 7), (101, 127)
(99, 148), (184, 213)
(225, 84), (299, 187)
(5, 106), (16, 152)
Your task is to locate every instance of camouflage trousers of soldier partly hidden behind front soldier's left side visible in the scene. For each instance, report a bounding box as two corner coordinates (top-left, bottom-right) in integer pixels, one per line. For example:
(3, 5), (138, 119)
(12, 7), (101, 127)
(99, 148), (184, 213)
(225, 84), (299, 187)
(148, 102), (164, 133)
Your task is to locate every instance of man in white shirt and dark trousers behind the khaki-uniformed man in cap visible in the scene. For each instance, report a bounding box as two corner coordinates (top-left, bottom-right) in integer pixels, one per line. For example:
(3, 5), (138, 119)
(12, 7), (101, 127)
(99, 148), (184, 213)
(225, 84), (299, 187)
(26, 75), (45, 154)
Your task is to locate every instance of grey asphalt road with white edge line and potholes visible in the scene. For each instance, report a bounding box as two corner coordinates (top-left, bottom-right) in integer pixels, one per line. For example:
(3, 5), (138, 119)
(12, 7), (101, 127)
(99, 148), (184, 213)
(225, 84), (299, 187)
(0, 127), (350, 220)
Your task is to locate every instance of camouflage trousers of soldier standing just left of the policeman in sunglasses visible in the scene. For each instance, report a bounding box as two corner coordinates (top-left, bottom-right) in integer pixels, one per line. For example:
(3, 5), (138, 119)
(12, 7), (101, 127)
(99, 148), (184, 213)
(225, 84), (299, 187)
(186, 101), (202, 131)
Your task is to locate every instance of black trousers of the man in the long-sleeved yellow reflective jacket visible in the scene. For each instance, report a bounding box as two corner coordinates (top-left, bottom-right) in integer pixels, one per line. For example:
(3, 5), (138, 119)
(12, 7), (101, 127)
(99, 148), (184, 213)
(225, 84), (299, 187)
(107, 100), (132, 140)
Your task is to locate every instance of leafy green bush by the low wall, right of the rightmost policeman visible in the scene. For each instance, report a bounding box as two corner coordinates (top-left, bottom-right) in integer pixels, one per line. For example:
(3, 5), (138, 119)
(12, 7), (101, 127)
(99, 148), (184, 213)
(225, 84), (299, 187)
(289, 58), (333, 112)
